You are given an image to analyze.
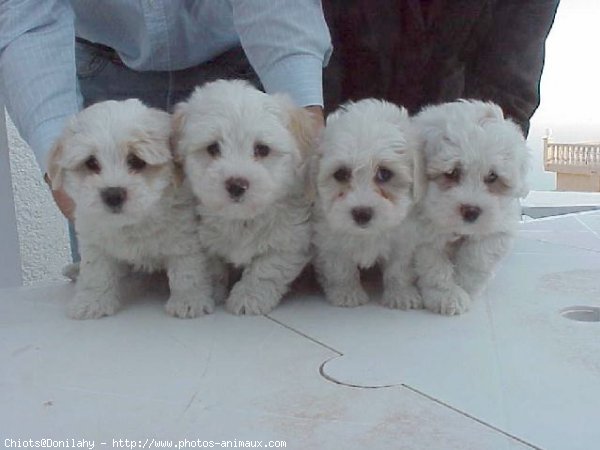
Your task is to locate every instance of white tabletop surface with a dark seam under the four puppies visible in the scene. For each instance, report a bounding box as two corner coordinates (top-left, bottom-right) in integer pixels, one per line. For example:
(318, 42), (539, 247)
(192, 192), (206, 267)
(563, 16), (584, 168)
(0, 212), (600, 450)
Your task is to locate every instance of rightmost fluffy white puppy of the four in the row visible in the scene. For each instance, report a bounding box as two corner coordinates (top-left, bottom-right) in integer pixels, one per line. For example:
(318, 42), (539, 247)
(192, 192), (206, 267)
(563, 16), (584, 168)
(414, 101), (529, 315)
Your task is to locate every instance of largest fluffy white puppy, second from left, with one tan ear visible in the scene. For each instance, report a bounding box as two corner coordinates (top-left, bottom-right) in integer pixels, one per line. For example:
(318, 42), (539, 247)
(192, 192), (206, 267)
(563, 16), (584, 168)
(173, 80), (317, 314)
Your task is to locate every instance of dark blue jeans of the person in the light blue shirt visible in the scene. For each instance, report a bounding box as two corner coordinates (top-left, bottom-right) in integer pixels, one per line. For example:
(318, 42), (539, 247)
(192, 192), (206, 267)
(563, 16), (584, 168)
(69, 42), (262, 262)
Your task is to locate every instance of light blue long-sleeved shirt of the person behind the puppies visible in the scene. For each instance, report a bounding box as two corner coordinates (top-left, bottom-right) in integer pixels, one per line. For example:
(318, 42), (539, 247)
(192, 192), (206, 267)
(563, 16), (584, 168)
(0, 0), (331, 167)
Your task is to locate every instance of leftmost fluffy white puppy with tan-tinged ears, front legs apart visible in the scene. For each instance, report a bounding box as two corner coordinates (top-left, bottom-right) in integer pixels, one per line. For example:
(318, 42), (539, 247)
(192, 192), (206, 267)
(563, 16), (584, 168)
(48, 99), (214, 319)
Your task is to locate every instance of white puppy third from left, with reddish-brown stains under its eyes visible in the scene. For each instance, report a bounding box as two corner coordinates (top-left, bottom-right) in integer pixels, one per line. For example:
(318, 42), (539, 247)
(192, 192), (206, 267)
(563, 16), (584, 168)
(313, 99), (422, 309)
